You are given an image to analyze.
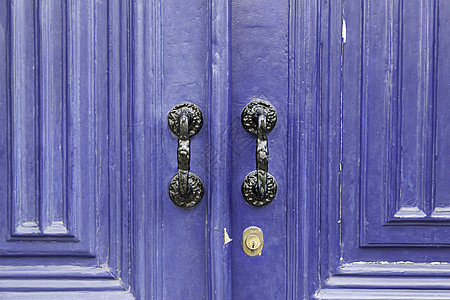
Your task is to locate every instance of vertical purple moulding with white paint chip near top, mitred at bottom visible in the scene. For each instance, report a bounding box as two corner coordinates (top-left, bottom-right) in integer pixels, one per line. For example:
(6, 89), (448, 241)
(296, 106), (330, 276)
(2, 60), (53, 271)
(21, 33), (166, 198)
(309, 0), (351, 297)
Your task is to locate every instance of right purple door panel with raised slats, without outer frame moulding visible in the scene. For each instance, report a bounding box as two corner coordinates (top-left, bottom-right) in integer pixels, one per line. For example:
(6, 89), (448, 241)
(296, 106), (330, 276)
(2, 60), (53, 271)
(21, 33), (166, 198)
(361, 1), (450, 247)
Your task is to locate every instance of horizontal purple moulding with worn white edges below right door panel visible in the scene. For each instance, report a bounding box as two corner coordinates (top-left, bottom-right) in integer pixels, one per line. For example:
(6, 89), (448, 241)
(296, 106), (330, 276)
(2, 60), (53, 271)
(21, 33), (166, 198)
(315, 262), (450, 299)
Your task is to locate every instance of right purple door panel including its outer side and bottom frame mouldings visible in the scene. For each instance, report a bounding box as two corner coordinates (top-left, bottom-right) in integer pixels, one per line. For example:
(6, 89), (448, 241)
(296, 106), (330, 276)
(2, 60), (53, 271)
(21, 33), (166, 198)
(316, 0), (450, 299)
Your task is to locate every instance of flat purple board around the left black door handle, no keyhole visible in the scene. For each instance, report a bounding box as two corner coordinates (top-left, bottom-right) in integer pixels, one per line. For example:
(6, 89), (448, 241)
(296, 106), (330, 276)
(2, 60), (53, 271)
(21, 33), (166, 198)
(162, 0), (210, 299)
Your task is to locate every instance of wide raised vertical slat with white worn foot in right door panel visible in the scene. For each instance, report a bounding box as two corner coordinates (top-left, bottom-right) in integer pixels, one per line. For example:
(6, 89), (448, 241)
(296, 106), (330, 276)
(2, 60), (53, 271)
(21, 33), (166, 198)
(386, 0), (438, 221)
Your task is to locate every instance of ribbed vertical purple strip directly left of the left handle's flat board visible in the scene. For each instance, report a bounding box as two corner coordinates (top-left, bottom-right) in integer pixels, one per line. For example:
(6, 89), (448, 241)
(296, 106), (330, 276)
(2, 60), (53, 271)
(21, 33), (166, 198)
(126, 0), (163, 299)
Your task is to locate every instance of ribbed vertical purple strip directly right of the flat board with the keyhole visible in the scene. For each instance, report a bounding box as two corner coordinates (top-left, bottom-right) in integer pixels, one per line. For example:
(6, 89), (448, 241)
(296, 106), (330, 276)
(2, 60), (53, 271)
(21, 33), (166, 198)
(286, 0), (322, 299)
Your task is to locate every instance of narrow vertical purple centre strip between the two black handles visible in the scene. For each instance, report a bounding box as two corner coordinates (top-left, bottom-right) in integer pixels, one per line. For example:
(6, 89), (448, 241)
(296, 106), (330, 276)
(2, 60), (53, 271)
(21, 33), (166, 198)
(206, 0), (232, 299)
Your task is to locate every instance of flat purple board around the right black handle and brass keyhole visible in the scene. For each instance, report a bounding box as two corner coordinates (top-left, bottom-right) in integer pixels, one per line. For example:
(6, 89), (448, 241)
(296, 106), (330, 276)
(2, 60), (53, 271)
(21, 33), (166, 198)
(231, 1), (288, 299)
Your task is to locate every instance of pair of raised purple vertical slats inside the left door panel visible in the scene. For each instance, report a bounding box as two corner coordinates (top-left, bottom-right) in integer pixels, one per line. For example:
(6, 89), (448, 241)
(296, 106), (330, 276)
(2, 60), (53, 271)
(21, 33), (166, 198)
(11, 2), (74, 236)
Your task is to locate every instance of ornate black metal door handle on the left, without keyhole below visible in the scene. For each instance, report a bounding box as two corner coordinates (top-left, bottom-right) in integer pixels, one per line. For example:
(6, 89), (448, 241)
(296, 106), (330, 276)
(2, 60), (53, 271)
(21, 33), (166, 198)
(168, 102), (203, 208)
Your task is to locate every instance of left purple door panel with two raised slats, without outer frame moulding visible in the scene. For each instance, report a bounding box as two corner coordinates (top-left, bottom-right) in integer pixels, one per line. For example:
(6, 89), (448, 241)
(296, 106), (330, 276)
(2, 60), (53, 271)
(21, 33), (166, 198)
(0, 1), (96, 256)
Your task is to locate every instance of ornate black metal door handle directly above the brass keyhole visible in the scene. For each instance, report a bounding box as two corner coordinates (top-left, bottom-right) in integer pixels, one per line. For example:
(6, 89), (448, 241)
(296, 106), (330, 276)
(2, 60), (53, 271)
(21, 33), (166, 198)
(241, 99), (277, 206)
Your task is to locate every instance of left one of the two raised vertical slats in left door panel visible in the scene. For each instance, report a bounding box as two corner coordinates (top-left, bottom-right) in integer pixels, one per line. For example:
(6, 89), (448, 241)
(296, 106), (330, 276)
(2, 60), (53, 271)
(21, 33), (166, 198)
(10, 0), (41, 235)
